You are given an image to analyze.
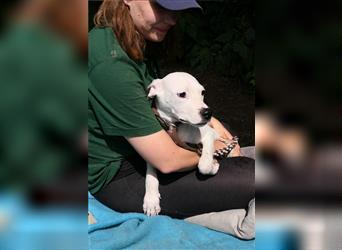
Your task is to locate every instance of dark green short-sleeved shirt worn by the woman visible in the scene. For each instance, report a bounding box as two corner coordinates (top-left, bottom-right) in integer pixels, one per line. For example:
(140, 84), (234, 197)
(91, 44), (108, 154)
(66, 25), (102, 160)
(88, 28), (162, 194)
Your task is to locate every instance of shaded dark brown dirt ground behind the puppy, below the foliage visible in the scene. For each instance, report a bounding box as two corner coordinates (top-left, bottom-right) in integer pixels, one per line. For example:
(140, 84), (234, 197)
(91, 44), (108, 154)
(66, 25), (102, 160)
(161, 65), (255, 146)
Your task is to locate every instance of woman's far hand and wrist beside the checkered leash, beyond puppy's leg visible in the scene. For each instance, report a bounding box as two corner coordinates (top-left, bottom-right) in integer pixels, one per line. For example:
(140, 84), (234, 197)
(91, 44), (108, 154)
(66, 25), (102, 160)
(209, 117), (241, 156)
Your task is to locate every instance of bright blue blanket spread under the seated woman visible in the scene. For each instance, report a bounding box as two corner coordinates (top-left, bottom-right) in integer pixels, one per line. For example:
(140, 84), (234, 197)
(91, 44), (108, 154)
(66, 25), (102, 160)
(88, 196), (254, 250)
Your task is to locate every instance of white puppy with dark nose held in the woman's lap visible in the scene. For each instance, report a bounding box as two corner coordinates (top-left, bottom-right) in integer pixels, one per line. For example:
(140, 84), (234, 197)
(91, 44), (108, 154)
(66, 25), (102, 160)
(143, 72), (219, 216)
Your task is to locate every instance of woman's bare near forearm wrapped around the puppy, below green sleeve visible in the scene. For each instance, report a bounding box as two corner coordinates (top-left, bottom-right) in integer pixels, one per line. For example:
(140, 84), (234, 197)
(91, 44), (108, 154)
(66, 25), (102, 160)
(126, 130), (199, 174)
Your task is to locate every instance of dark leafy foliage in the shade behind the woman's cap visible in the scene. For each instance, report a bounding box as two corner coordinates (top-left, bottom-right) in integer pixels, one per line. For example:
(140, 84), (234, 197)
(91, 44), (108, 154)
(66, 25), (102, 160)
(169, 0), (255, 86)
